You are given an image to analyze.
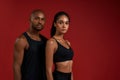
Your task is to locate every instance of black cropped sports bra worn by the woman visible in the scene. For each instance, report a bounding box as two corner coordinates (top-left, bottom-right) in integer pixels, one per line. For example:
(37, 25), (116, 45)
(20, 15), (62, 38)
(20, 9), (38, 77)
(53, 38), (74, 63)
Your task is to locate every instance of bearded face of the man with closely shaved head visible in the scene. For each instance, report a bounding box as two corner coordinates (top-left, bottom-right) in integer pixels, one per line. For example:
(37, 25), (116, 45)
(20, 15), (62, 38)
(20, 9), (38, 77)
(30, 12), (45, 31)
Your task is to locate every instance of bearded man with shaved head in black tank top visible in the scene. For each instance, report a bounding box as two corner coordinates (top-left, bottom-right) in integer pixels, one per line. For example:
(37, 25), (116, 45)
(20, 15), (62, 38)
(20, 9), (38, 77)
(13, 9), (47, 80)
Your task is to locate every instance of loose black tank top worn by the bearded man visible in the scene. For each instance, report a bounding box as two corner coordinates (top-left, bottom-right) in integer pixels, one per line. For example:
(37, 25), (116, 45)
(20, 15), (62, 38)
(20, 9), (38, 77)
(21, 32), (47, 80)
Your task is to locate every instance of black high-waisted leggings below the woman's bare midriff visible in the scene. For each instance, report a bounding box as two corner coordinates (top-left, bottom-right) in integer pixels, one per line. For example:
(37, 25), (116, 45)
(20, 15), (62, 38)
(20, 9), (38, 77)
(53, 70), (71, 80)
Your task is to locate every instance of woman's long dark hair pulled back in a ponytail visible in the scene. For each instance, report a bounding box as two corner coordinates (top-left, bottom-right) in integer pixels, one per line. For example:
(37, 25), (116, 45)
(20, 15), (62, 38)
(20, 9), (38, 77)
(50, 11), (70, 37)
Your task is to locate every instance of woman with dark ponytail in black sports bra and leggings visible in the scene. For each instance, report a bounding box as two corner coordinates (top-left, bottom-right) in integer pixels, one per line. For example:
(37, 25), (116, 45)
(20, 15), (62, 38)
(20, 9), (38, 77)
(46, 11), (73, 80)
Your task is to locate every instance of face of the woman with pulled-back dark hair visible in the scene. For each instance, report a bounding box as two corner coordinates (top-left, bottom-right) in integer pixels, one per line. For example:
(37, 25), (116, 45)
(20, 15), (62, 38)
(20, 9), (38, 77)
(54, 15), (69, 34)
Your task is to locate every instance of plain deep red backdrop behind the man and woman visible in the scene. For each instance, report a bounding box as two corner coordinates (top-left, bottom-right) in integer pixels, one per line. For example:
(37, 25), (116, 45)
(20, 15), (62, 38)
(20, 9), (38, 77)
(0, 0), (120, 80)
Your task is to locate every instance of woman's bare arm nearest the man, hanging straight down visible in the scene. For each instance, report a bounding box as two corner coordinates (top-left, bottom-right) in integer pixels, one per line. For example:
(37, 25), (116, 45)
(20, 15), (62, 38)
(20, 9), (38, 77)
(46, 39), (55, 80)
